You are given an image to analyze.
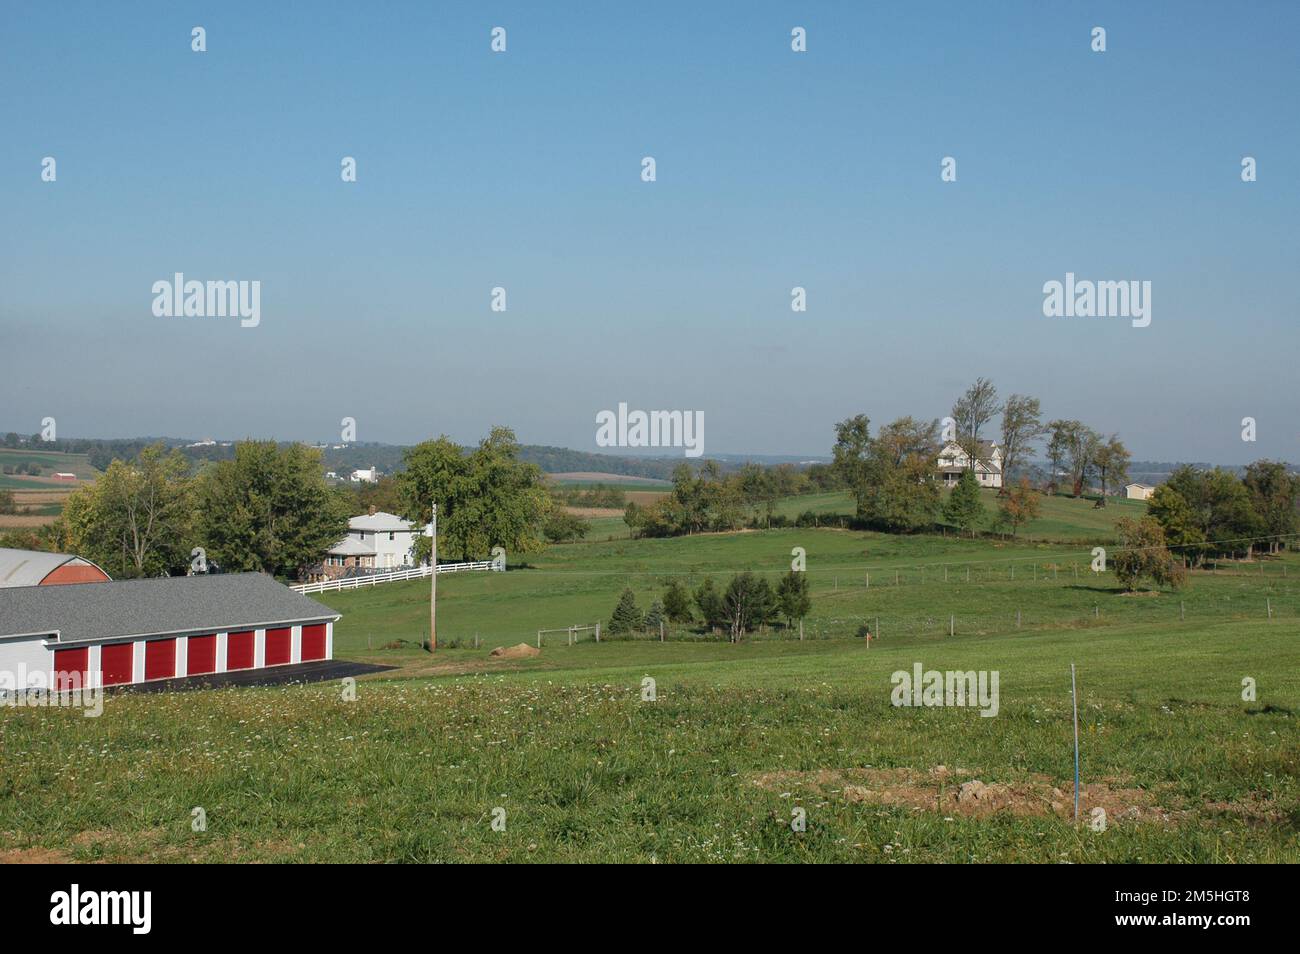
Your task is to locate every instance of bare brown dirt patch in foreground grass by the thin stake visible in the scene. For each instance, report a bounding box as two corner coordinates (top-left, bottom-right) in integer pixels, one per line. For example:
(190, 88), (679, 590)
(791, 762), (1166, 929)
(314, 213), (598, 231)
(755, 766), (1186, 824)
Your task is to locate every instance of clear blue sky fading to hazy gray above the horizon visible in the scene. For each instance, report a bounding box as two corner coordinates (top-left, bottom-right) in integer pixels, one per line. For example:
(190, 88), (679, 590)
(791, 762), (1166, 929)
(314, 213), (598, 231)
(0, 3), (1300, 463)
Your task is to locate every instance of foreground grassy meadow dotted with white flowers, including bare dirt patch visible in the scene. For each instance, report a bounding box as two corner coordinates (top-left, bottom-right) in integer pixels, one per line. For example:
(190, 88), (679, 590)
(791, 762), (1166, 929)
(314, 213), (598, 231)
(0, 613), (1300, 863)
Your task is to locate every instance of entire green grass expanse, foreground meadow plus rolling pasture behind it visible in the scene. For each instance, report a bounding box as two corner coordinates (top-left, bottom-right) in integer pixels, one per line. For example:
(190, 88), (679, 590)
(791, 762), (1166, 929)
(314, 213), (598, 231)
(0, 496), (1300, 863)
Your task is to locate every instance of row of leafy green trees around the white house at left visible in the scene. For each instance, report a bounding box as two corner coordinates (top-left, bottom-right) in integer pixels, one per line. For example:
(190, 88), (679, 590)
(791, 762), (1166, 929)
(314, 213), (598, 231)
(0, 428), (550, 578)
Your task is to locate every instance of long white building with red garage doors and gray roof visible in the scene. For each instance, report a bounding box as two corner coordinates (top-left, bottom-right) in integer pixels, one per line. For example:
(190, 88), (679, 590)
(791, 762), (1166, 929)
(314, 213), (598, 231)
(0, 573), (339, 689)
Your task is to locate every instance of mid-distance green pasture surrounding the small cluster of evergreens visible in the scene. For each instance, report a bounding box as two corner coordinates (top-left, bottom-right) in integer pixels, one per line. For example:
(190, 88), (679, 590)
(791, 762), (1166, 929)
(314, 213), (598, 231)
(320, 519), (1300, 662)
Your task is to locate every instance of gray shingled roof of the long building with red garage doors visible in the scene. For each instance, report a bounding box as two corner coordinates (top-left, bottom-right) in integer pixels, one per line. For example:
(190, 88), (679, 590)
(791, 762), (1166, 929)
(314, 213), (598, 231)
(0, 573), (339, 642)
